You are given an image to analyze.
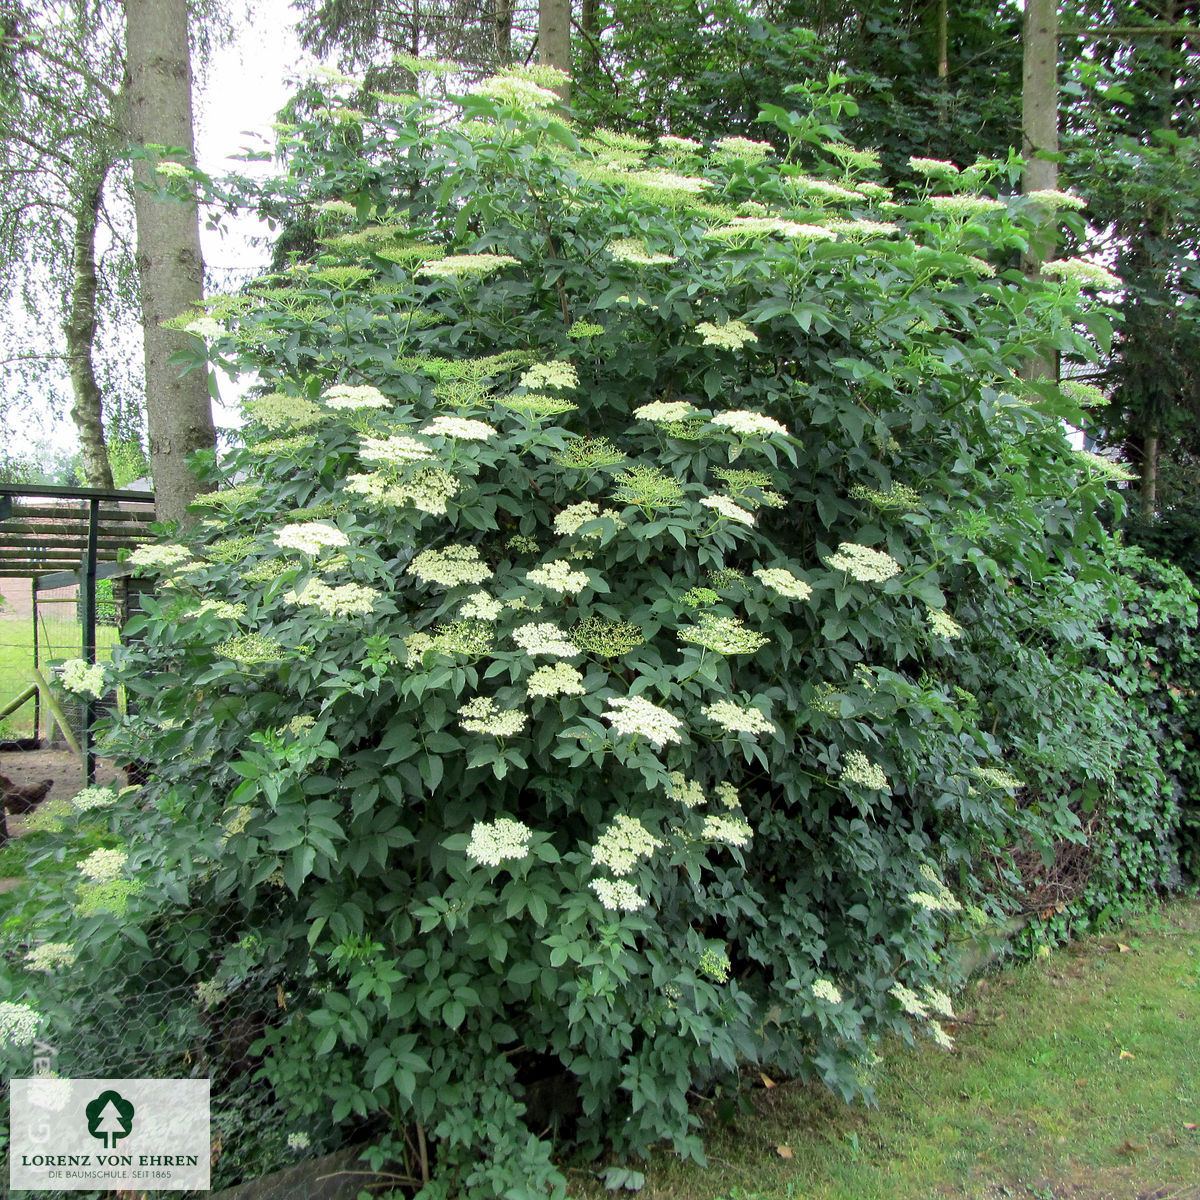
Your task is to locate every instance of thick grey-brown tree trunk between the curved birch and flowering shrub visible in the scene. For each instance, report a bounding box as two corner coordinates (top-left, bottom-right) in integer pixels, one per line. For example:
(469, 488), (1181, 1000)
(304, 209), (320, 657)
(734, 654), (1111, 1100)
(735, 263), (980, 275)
(125, 0), (216, 521)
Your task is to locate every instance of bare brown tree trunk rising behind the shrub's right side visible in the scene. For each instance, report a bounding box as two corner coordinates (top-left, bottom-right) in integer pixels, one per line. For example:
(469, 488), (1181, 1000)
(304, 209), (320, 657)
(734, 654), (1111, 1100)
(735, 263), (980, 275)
(1021, 0), (1058, 380)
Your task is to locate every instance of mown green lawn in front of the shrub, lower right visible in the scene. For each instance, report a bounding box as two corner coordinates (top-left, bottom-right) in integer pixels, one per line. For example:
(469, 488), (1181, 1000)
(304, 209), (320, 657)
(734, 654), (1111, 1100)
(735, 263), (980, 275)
(571, 901), (1200, 1200)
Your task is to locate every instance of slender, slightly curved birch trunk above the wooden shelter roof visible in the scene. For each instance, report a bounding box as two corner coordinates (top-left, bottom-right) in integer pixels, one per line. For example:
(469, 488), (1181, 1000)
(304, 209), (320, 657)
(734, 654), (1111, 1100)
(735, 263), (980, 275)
(65, 162), (113, 487)
